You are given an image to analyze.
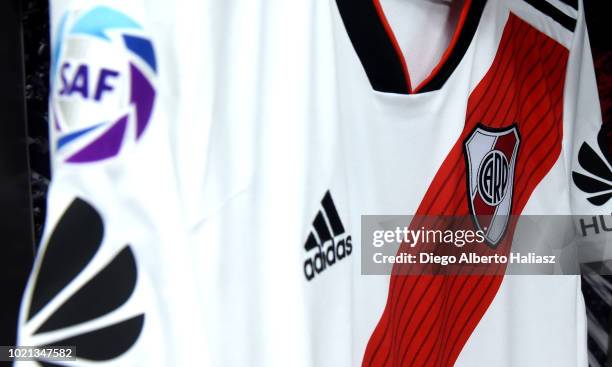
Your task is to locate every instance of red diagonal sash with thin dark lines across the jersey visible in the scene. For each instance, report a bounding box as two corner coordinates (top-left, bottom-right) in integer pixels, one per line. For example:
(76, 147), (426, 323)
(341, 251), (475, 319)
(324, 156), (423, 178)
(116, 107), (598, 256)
(363, 15), (568, 366)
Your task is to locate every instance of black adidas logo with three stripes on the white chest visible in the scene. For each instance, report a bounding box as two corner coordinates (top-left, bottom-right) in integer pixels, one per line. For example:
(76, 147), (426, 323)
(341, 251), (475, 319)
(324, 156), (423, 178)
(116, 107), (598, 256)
(304, 190), (353, 281)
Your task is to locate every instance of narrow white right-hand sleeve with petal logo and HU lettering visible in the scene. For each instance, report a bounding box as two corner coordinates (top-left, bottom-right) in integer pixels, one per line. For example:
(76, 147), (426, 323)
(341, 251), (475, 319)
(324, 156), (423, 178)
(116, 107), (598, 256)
(564, 3), (612, 263)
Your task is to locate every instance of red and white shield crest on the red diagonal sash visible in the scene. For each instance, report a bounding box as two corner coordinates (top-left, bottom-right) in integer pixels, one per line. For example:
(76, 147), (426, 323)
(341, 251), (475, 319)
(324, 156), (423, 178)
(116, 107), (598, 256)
(464, 124), (521, 246)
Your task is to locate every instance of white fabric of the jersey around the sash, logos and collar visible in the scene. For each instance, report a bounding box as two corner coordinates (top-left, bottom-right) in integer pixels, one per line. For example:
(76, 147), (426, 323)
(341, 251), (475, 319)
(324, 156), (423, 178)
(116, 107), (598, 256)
(19, 0), (610, 367)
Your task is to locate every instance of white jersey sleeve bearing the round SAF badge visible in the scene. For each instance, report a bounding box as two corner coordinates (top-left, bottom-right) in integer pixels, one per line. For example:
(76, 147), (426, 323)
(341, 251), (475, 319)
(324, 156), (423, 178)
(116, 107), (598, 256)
(18, 0), (213, 366)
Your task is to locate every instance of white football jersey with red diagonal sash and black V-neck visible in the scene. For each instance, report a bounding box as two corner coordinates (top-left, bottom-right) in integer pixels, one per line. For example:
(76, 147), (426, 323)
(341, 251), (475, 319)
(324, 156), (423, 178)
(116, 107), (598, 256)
(19, 0), (612, 367)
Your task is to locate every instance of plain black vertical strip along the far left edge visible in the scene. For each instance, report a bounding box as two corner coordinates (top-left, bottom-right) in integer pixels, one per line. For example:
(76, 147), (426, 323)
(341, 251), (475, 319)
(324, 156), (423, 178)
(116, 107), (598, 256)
(0, 0), (34, 354)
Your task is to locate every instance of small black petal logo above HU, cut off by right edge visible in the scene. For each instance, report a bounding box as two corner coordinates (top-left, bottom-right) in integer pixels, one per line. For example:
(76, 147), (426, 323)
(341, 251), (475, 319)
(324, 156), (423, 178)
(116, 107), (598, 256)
(572, 124), (612, 206)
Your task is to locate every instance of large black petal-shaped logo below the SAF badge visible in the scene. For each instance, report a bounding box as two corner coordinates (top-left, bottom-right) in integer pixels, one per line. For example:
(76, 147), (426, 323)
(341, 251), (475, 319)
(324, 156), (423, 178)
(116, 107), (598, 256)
(19, 198), (145, 365)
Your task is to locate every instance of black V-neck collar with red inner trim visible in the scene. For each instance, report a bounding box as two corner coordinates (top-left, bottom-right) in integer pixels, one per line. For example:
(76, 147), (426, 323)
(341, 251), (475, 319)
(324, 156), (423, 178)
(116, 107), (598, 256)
(336, 0), (486, 94)
